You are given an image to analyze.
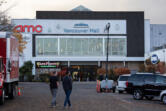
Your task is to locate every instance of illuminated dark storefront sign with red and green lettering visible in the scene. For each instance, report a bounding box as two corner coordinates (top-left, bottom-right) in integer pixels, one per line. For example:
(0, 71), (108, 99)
(36, 61), (60, 68)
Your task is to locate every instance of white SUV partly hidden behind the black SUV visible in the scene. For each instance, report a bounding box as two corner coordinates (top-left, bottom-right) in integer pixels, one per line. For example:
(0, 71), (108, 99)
(116, 74), (130, 93)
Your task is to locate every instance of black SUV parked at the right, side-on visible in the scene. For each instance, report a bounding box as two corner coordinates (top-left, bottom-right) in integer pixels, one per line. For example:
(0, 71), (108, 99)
(126, 73), (166, 100)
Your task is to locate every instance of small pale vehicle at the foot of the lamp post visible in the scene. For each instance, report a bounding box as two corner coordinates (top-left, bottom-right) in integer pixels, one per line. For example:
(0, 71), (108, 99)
(100, 80), (116, 93)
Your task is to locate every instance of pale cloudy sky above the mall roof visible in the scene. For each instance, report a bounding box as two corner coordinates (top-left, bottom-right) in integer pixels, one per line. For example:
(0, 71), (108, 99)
(0, 0), (166, 24)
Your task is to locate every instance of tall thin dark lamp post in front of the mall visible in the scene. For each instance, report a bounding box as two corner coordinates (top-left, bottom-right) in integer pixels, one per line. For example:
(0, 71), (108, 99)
(105, 22), (110, 80)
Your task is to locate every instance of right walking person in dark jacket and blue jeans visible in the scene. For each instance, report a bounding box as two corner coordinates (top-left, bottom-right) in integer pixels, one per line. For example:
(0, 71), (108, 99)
(63, 72), (72, 107)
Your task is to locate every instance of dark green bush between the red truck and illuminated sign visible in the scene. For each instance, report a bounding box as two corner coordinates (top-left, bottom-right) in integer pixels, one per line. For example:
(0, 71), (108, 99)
(19, 61), (33, 81)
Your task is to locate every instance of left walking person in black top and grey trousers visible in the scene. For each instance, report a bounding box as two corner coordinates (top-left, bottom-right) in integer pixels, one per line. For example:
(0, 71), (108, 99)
(50, 71), (59, 107)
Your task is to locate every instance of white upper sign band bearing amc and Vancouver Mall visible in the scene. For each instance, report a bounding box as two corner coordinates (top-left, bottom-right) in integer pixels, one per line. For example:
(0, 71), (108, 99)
(12, 19), (127, 34)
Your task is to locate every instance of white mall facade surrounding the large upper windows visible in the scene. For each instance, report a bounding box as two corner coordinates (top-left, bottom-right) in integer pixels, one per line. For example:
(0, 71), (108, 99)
(12, 19), (150, 74)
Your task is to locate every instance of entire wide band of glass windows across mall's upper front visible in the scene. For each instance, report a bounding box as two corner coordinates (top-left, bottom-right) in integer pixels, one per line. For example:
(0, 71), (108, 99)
(36, 37), (126, 56)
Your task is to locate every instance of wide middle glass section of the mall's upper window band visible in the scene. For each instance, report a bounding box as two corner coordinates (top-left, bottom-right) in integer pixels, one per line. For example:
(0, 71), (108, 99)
(60, 38), (103, 56)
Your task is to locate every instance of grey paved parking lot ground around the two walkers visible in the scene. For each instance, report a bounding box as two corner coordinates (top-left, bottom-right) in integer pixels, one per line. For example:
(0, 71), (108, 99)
(0, 82), (166, 111)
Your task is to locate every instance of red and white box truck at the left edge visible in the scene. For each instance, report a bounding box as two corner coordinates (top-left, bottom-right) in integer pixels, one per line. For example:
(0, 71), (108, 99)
(0, 32), (19, 103)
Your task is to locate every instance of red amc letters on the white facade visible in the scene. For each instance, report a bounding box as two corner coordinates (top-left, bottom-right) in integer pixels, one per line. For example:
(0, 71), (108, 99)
(14, 25), (43, 33)
